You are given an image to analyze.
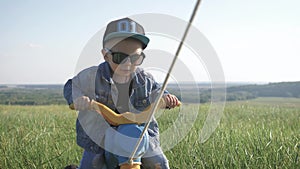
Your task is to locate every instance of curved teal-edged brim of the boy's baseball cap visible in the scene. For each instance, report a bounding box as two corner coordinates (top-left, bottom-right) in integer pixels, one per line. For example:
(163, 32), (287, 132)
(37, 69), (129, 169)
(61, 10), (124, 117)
(104, 32), (150, 48)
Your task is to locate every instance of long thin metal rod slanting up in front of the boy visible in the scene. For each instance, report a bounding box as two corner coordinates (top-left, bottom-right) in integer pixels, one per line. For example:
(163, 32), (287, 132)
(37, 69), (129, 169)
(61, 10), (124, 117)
(128, 0), (201, 163)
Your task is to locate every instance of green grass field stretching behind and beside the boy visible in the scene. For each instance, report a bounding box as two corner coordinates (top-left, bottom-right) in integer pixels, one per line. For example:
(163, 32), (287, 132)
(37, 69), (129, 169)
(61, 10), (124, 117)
(0, 98), (300, 169)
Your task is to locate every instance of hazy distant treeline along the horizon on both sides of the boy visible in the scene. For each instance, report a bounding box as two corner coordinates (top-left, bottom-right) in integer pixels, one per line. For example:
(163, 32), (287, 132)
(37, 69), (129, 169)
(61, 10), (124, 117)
(0, 82), (300, 105)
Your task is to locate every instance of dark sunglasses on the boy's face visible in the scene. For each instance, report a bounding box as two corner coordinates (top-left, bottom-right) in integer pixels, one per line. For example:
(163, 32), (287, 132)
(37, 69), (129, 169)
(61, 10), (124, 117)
(106, 49), (146, 66)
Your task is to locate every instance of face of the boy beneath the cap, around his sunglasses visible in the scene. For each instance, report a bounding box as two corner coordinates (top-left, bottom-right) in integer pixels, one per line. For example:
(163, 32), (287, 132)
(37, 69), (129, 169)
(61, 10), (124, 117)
(102, 39), (143, 77)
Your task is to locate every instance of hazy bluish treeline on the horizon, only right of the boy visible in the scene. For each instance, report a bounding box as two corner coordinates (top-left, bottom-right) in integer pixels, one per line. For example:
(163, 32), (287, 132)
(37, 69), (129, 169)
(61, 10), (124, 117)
(169, 82), (300, 103)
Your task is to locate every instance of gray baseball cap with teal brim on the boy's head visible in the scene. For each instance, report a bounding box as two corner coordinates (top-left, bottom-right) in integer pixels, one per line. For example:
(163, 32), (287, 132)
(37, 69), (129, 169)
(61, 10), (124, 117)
(103, 18), (150, 49)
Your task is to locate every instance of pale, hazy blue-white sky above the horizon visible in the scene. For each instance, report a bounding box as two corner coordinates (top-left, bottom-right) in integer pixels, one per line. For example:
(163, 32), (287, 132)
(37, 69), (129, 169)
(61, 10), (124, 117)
(0, 0), (300, 84)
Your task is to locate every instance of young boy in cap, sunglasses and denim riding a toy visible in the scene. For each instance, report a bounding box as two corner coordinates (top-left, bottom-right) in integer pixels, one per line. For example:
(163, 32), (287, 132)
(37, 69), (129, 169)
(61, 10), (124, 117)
(64, 18), (179, 169)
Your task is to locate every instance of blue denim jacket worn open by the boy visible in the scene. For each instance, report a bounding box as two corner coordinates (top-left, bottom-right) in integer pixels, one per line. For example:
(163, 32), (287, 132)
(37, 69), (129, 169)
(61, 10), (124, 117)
(64, 62), (168, 153)
